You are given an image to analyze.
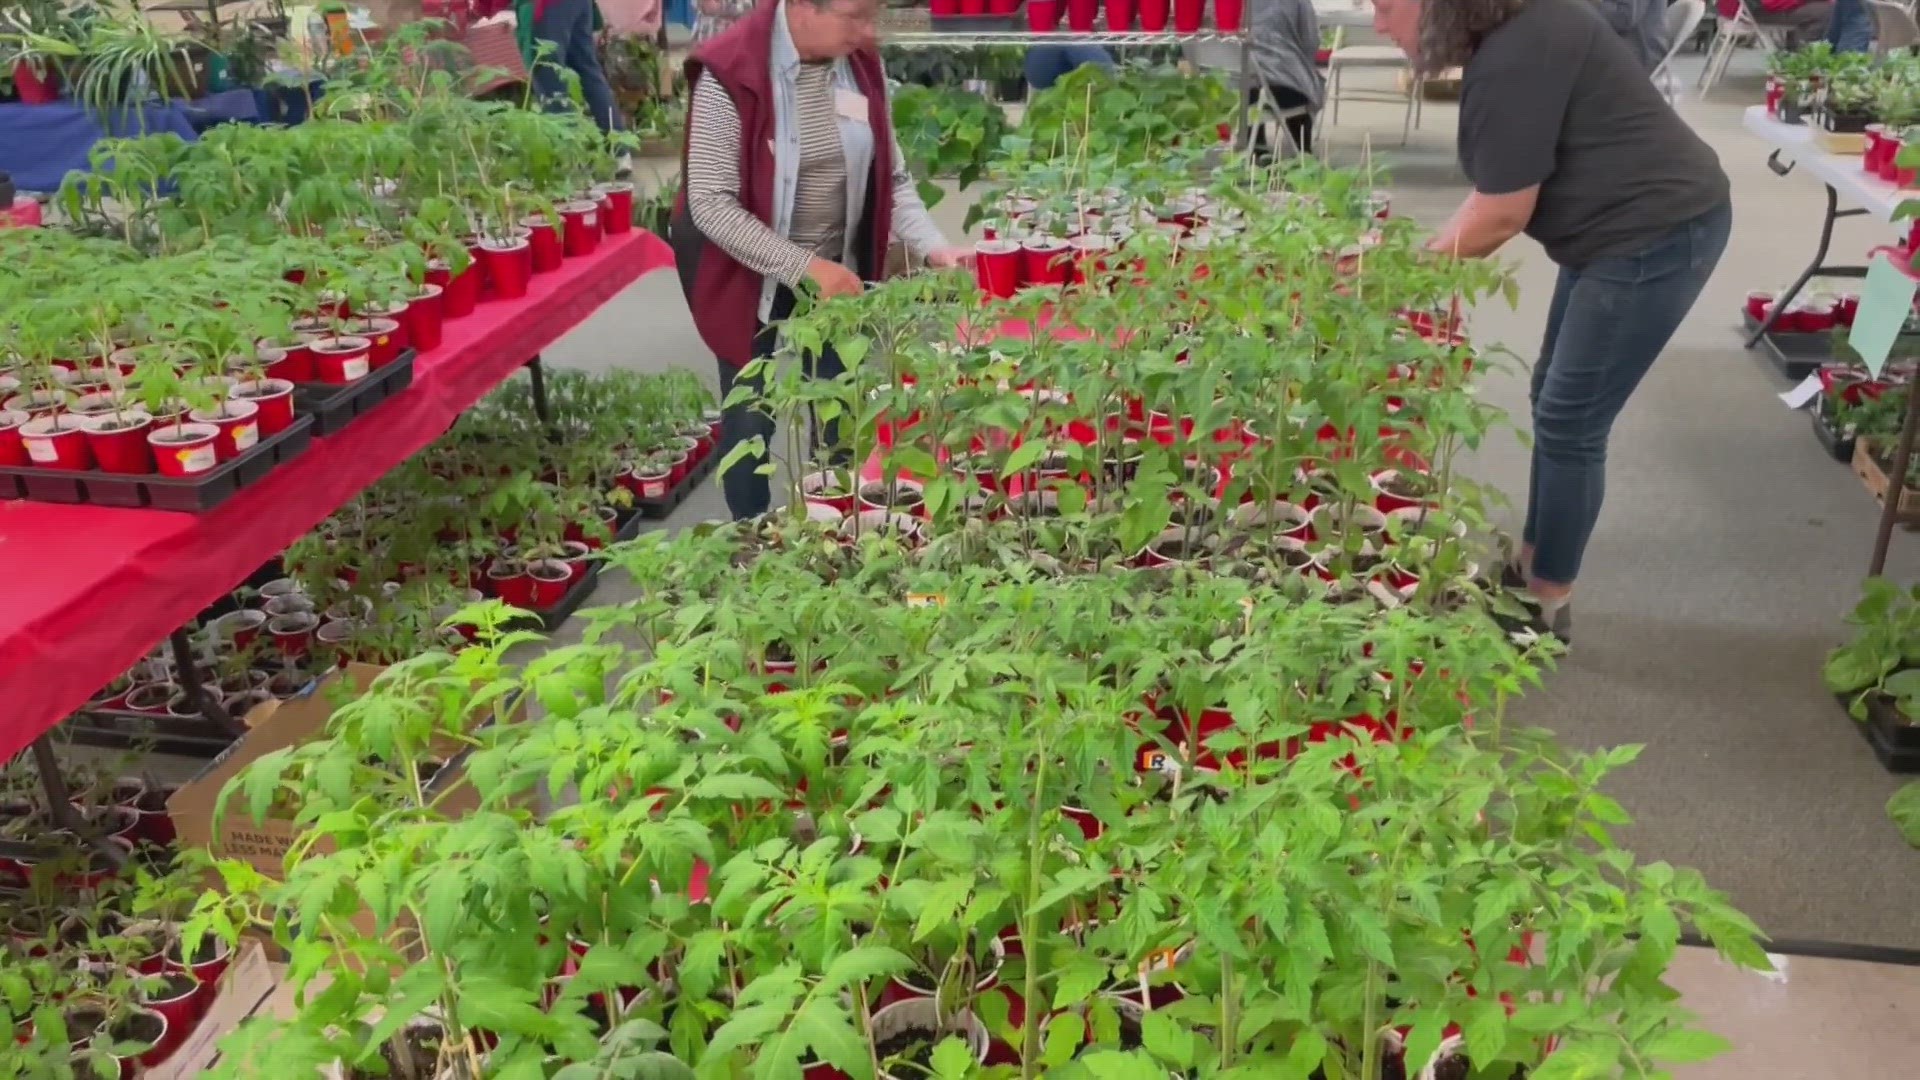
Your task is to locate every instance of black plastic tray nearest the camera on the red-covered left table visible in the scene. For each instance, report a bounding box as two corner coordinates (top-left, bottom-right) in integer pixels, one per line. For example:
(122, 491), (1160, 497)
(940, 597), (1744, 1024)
(0, 417), (313, 513)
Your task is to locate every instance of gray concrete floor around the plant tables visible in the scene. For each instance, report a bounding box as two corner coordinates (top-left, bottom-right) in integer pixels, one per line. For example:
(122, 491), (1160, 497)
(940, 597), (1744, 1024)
(510, 44), (1920, 1080)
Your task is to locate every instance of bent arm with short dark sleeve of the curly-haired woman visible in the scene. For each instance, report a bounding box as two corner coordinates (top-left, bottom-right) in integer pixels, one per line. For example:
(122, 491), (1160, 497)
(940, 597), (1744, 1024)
(1427, 42), (1574, 259)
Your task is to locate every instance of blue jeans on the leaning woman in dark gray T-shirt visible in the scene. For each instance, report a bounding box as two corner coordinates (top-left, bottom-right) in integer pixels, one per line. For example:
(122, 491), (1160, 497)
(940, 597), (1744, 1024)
(1521, 204), (1734, 584)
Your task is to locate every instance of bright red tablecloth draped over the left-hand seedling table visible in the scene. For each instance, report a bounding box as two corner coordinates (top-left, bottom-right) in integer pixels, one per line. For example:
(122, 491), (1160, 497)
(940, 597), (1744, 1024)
(0, 231), (674, 761)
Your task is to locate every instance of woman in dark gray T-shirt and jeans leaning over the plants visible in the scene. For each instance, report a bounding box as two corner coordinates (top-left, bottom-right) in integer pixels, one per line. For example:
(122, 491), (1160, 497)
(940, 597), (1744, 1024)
(1373, 0), (1734, 638)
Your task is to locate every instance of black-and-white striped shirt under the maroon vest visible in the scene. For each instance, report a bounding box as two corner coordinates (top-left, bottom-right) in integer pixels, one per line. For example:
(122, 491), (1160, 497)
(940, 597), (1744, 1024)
(687, 63), (947, 286)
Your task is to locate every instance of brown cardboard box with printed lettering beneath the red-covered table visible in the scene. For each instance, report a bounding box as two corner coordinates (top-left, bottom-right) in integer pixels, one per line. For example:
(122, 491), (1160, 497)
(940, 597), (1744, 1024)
(167, 663), (480, 878)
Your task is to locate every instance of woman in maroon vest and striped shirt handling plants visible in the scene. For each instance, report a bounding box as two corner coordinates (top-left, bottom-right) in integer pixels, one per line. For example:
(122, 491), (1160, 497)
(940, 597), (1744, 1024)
(670, 0), (972, 519)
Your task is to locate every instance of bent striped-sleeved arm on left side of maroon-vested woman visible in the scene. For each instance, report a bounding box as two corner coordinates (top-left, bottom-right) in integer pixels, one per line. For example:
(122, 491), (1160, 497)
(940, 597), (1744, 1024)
(687, 75), (814, 286)
